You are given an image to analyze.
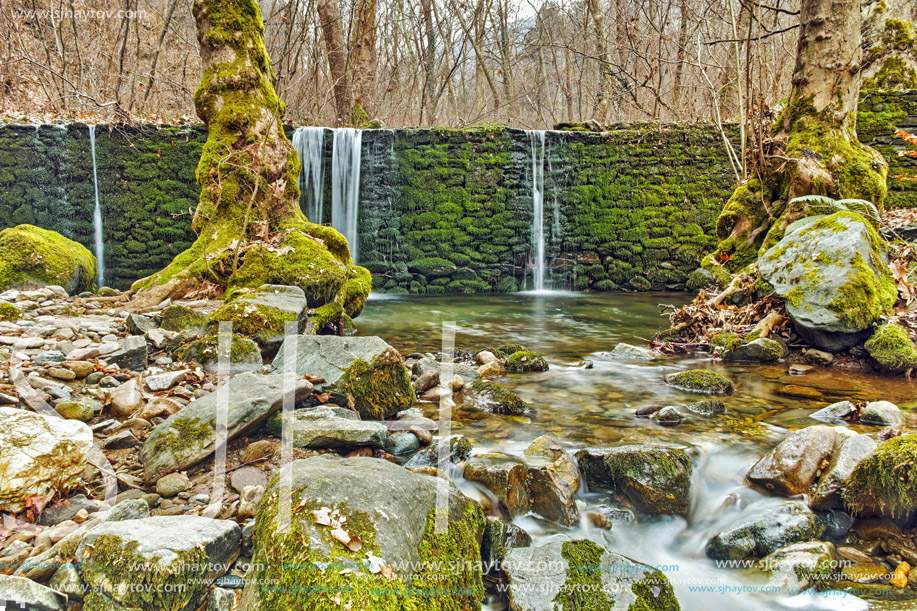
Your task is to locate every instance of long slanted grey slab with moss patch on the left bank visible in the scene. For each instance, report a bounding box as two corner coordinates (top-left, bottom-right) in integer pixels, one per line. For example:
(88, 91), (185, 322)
(140, 373), (312, 482)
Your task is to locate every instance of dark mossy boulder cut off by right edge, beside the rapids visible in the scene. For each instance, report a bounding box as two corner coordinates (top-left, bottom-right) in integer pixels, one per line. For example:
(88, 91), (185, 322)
(843, 433), (917, 522)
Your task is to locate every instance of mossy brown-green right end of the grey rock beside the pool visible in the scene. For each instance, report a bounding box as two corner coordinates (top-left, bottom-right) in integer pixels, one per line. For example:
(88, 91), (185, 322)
(335, 348), (417, 420)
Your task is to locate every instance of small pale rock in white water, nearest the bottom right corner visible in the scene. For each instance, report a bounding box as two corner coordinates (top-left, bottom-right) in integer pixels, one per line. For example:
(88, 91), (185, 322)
(760, 541), (834, 592)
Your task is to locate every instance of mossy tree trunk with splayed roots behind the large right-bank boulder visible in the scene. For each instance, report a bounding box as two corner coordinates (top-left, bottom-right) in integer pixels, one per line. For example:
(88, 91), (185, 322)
(704, 0), (888, 273)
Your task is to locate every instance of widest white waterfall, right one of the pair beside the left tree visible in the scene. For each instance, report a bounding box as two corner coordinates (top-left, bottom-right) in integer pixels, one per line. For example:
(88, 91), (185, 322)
(331, 127), (363, 263)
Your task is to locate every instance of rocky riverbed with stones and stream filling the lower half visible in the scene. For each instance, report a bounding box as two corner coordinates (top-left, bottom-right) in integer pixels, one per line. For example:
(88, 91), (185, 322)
(0, 287), (917, 611)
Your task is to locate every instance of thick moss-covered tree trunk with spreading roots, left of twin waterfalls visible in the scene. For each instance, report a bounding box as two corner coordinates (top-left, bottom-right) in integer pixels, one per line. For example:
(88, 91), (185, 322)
(132, 0), (369, 316)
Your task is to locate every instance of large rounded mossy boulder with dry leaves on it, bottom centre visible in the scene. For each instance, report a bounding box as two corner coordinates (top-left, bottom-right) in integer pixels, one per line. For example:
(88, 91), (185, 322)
(239, 456), (484, 611)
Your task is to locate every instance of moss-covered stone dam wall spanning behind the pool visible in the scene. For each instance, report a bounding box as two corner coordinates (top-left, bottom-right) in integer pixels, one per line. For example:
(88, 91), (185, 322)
(0, 92), (917, 293)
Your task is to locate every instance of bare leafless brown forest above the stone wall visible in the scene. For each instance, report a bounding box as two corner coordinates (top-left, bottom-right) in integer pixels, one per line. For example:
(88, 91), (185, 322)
(0, 0), (914, 129)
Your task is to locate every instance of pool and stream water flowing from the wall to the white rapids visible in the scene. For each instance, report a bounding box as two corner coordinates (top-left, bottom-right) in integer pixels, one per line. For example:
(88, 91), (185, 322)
(357, 292), (917, 611)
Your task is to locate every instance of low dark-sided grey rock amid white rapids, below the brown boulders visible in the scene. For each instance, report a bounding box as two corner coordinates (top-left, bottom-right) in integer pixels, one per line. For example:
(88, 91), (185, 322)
(706, 498), (825, 560)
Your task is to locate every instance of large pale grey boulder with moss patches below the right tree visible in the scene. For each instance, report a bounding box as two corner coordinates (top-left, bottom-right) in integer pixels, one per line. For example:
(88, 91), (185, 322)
(758, 211), (898, 352)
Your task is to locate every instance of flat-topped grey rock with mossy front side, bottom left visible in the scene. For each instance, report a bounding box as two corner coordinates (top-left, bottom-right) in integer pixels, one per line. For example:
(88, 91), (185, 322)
(76, 516), (242, 611)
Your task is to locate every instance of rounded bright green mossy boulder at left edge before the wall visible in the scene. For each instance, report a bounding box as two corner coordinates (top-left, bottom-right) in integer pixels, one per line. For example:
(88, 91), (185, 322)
(0, 225), (96, 295)
